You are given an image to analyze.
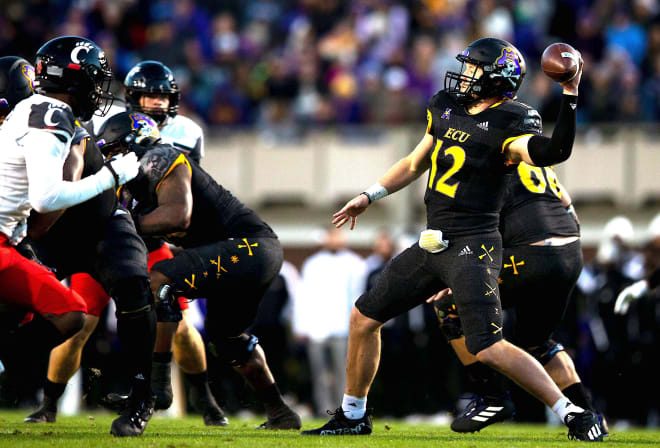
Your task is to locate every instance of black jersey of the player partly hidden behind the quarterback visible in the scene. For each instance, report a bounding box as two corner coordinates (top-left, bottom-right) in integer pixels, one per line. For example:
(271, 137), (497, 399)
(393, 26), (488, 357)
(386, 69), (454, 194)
(500, 163), (580, 247)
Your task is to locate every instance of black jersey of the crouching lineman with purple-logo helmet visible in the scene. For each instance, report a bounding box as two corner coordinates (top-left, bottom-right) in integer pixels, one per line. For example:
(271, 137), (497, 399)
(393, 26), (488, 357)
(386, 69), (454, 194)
(127, 143), (275, 248)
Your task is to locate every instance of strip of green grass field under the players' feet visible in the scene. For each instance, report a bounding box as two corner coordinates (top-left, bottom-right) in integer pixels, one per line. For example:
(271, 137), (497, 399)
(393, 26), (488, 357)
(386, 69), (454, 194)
(0, 411), (660, 448)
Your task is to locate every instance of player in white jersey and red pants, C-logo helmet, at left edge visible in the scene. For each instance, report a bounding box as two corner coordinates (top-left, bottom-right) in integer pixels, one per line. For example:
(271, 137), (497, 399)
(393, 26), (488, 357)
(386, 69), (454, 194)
(0, 36), (139, 400)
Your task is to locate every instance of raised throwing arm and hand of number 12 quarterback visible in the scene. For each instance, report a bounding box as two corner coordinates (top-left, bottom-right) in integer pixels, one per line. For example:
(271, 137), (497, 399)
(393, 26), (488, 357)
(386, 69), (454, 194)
(504, 57), (584, 166)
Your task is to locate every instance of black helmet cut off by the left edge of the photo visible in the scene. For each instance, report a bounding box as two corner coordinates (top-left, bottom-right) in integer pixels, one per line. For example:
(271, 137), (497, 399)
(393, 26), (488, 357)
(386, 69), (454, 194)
(0, 56), (34, 117)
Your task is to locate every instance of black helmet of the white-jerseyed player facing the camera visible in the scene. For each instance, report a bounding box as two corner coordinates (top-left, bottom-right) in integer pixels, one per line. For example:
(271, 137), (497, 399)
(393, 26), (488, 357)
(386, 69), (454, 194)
(124, 61), (181, 125)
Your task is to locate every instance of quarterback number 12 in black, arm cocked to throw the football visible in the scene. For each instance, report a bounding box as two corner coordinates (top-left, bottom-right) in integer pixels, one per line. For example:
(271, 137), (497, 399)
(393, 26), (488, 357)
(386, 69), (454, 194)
(303, 38), (602, 440)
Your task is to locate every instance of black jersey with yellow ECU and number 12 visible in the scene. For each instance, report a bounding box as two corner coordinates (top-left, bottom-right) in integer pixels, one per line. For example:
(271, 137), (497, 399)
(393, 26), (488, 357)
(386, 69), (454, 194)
(424, 91), (542, 237)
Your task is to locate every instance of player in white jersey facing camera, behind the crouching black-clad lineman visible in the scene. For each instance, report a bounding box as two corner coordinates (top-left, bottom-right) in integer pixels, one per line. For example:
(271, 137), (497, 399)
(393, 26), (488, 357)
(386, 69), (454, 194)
(36, 61), (228, 426)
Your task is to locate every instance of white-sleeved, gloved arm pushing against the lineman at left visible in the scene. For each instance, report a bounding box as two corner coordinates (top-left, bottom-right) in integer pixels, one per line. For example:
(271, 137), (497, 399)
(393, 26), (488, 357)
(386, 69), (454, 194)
(20, 131), (140, 213)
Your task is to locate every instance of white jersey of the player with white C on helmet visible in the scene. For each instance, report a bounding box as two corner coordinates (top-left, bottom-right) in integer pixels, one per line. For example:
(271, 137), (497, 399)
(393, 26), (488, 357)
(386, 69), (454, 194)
(0, 95), (75, 244)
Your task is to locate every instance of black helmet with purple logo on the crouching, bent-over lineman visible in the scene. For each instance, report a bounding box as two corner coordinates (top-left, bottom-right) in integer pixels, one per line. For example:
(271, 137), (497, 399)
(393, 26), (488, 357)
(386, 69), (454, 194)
(96, 112), (160, 158)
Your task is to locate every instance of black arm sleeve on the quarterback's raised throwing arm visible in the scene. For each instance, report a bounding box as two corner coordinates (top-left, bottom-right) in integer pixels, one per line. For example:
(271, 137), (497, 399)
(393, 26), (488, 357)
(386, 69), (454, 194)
(527, 95), (577, 166)
